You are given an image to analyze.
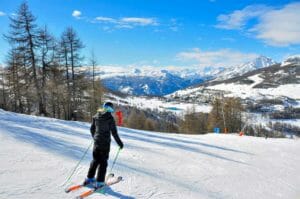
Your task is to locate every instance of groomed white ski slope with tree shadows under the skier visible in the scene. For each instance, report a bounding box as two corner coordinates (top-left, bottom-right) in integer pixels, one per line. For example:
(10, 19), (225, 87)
(0, 110), (300, 199)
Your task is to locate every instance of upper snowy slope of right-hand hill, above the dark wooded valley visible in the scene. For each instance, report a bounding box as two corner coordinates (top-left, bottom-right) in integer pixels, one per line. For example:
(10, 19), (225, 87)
(168, 57), (300, 102)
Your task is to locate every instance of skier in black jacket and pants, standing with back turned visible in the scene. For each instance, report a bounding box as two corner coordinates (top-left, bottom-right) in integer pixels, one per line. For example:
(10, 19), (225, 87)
(84, 102), (124, 188)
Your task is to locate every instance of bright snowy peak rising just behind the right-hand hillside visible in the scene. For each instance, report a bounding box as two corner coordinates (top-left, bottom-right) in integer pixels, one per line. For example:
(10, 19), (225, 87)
(215, 56), (276, 81)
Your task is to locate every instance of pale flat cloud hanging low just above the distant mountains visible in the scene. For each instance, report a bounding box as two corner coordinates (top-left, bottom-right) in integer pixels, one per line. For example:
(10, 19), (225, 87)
(176, 48), (259, 67)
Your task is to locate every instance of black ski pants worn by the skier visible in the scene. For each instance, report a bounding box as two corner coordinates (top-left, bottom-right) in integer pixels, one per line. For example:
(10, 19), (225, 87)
(87, 147), (109, 182)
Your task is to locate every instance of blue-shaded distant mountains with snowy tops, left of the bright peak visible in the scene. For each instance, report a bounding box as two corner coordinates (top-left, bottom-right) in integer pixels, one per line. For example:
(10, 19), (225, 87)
(100, 67), (207, 96)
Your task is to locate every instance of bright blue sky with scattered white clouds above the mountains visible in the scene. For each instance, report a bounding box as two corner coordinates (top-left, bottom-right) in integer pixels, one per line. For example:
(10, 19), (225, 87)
(0, 0), (300, 67)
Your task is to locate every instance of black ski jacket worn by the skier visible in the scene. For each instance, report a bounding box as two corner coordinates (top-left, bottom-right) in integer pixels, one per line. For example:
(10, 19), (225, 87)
(91, 111), (123, 151)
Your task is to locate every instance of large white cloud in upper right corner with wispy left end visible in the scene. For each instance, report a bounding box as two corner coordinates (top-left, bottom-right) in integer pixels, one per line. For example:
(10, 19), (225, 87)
(216, 2), (300, 46)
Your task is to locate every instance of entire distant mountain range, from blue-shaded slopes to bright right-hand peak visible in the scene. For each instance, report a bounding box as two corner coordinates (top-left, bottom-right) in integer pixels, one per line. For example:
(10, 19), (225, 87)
(79, 56), (275, 96)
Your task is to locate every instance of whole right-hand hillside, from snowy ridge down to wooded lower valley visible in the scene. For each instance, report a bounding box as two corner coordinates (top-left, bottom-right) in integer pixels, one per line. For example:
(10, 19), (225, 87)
(166, 57), (300, 135)
